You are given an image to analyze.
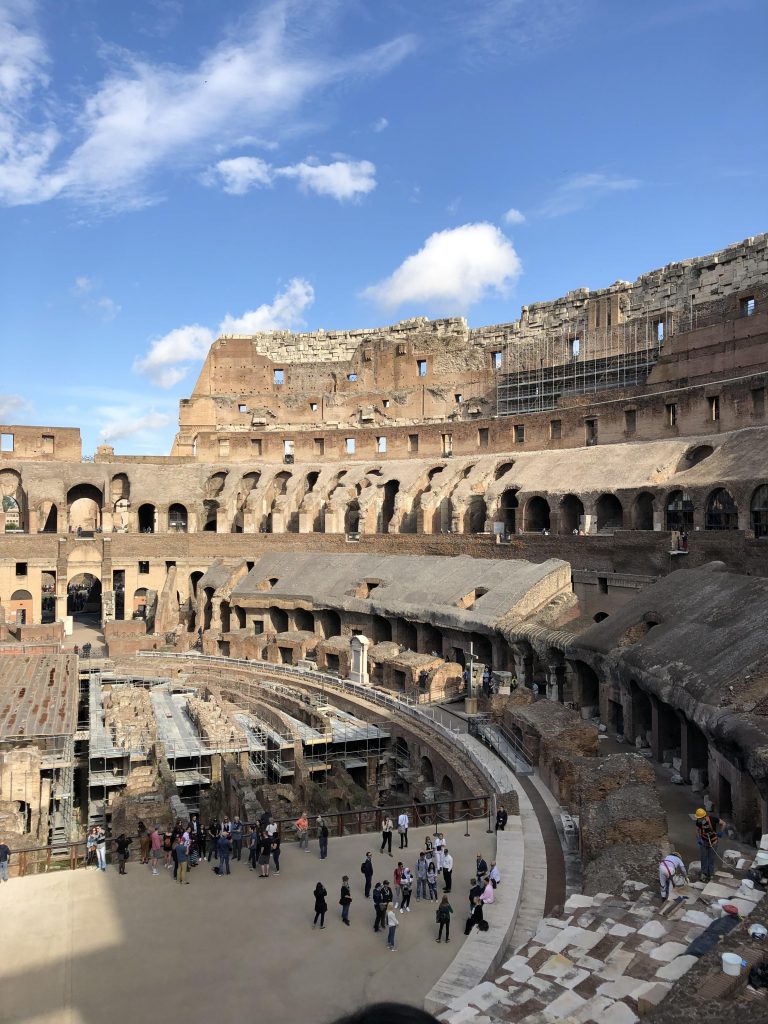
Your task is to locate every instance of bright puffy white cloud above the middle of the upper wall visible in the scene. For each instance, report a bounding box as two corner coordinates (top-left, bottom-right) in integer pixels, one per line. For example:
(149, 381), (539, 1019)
(362, 223), (522, 309)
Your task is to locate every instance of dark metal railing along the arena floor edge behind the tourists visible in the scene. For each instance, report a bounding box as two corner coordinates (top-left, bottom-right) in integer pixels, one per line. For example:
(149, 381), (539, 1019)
(3, 794), (493, 878)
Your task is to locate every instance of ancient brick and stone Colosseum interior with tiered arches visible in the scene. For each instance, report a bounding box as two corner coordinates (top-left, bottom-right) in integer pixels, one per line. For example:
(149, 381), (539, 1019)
(0, 234), (768, 1024)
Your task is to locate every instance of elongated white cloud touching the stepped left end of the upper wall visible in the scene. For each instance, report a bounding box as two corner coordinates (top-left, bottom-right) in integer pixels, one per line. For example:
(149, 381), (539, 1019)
(133, 278), (314, 388)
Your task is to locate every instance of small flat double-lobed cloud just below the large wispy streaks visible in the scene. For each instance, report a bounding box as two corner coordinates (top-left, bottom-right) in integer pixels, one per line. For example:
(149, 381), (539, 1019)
(202, 157), (376, 202)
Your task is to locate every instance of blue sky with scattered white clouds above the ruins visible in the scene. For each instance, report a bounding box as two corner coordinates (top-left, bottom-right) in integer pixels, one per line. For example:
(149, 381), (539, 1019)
(0, 0), (768, 454)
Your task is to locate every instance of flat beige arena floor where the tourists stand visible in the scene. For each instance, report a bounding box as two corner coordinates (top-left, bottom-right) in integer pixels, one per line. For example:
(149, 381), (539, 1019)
(0, 821), (504, 1024)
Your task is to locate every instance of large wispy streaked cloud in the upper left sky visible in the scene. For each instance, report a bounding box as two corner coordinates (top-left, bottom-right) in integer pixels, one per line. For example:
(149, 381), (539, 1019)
(0, 0), (414, 207)
